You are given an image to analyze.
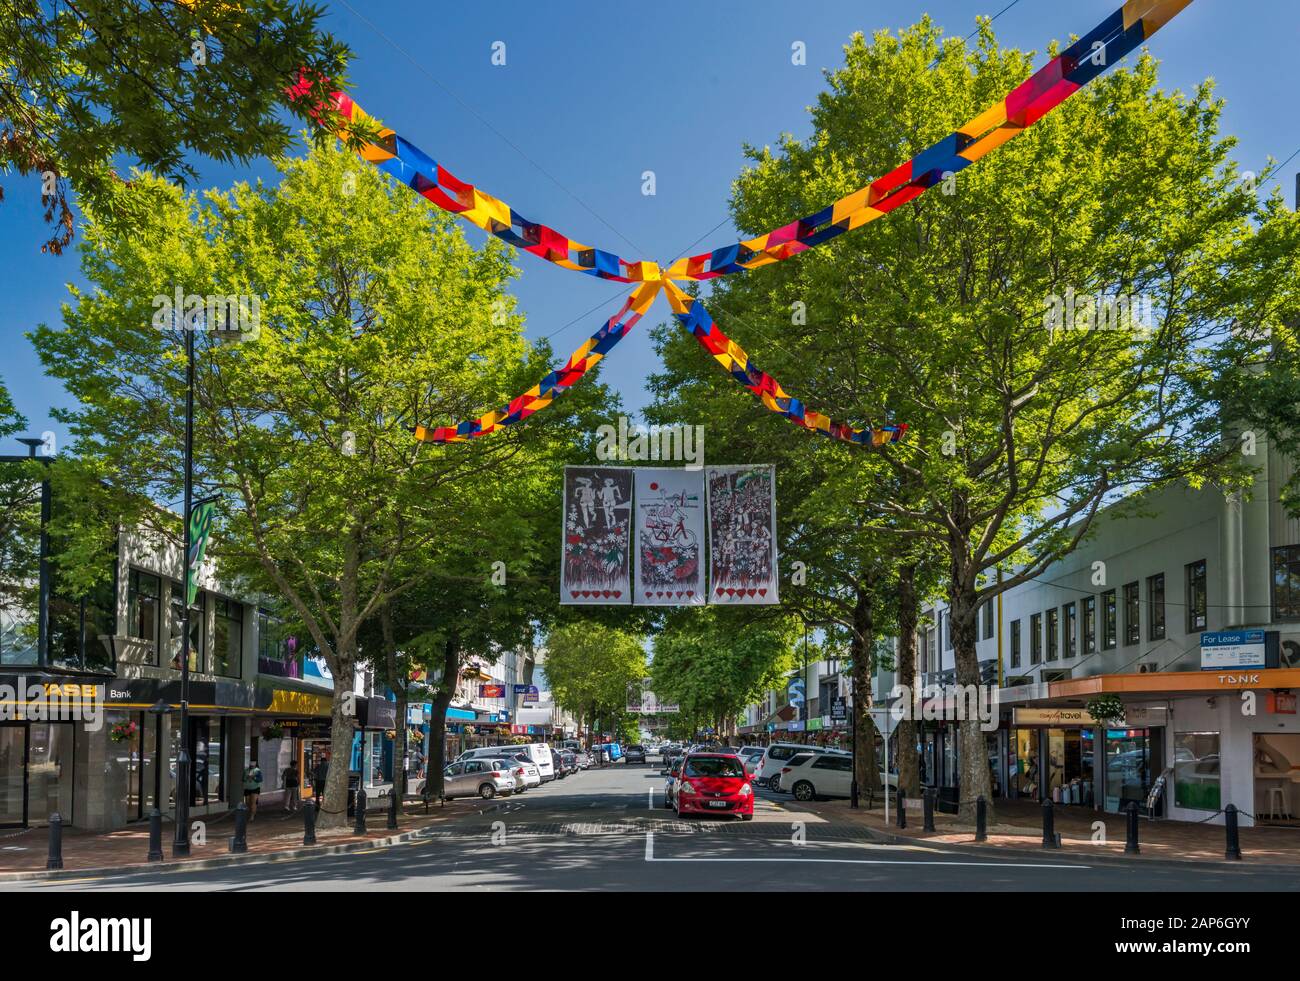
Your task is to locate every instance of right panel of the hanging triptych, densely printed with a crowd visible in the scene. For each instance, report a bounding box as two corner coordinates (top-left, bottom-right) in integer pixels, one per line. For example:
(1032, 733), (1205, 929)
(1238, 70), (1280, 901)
(705, 465), (780, 604)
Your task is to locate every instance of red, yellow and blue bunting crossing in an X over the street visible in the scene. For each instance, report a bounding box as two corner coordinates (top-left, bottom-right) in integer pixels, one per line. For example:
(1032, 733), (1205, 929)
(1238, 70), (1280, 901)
(289, 0), (1192, 446)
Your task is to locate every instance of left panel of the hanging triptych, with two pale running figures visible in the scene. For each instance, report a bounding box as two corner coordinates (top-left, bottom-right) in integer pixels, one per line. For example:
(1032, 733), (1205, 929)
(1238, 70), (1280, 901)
(560, 466), (632, 604)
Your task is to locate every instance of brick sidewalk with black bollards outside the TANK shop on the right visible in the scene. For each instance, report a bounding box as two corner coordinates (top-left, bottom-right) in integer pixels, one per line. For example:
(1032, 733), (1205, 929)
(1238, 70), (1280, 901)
(787, 798), (1300, 868)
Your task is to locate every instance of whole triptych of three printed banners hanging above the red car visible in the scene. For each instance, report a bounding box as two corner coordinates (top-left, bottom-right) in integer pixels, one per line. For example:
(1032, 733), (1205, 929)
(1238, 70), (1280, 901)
(560, 464), (779, 607)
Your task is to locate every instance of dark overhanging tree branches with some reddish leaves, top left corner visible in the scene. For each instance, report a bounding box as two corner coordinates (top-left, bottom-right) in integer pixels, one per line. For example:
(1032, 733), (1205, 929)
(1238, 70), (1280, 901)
(0, 0), (361, 253)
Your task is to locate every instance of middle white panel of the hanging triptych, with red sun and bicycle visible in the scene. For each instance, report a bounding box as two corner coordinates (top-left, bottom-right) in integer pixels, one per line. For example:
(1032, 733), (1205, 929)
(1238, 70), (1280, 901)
(632, 468), (707, 607)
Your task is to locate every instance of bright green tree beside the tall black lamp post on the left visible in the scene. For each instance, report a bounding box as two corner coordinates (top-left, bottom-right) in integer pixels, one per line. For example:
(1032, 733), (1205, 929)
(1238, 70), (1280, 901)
(33, 147), (595, 821)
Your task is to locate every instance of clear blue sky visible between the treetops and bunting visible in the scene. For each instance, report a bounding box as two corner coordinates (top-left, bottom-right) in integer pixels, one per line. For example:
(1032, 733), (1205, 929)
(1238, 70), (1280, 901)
(0, 0), (1300, 448)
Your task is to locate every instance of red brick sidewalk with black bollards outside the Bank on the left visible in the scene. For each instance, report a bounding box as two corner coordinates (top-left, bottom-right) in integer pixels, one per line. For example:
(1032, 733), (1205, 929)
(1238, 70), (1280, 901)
(0, 798), (488, 881)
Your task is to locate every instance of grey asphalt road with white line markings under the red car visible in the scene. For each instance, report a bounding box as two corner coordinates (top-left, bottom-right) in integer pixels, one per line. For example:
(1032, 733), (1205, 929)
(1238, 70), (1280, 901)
(10, 763), (1300, 895)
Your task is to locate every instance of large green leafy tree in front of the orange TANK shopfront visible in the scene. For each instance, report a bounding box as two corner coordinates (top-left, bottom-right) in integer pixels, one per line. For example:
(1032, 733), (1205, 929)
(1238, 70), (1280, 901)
(660, 19), (1296, 813)
